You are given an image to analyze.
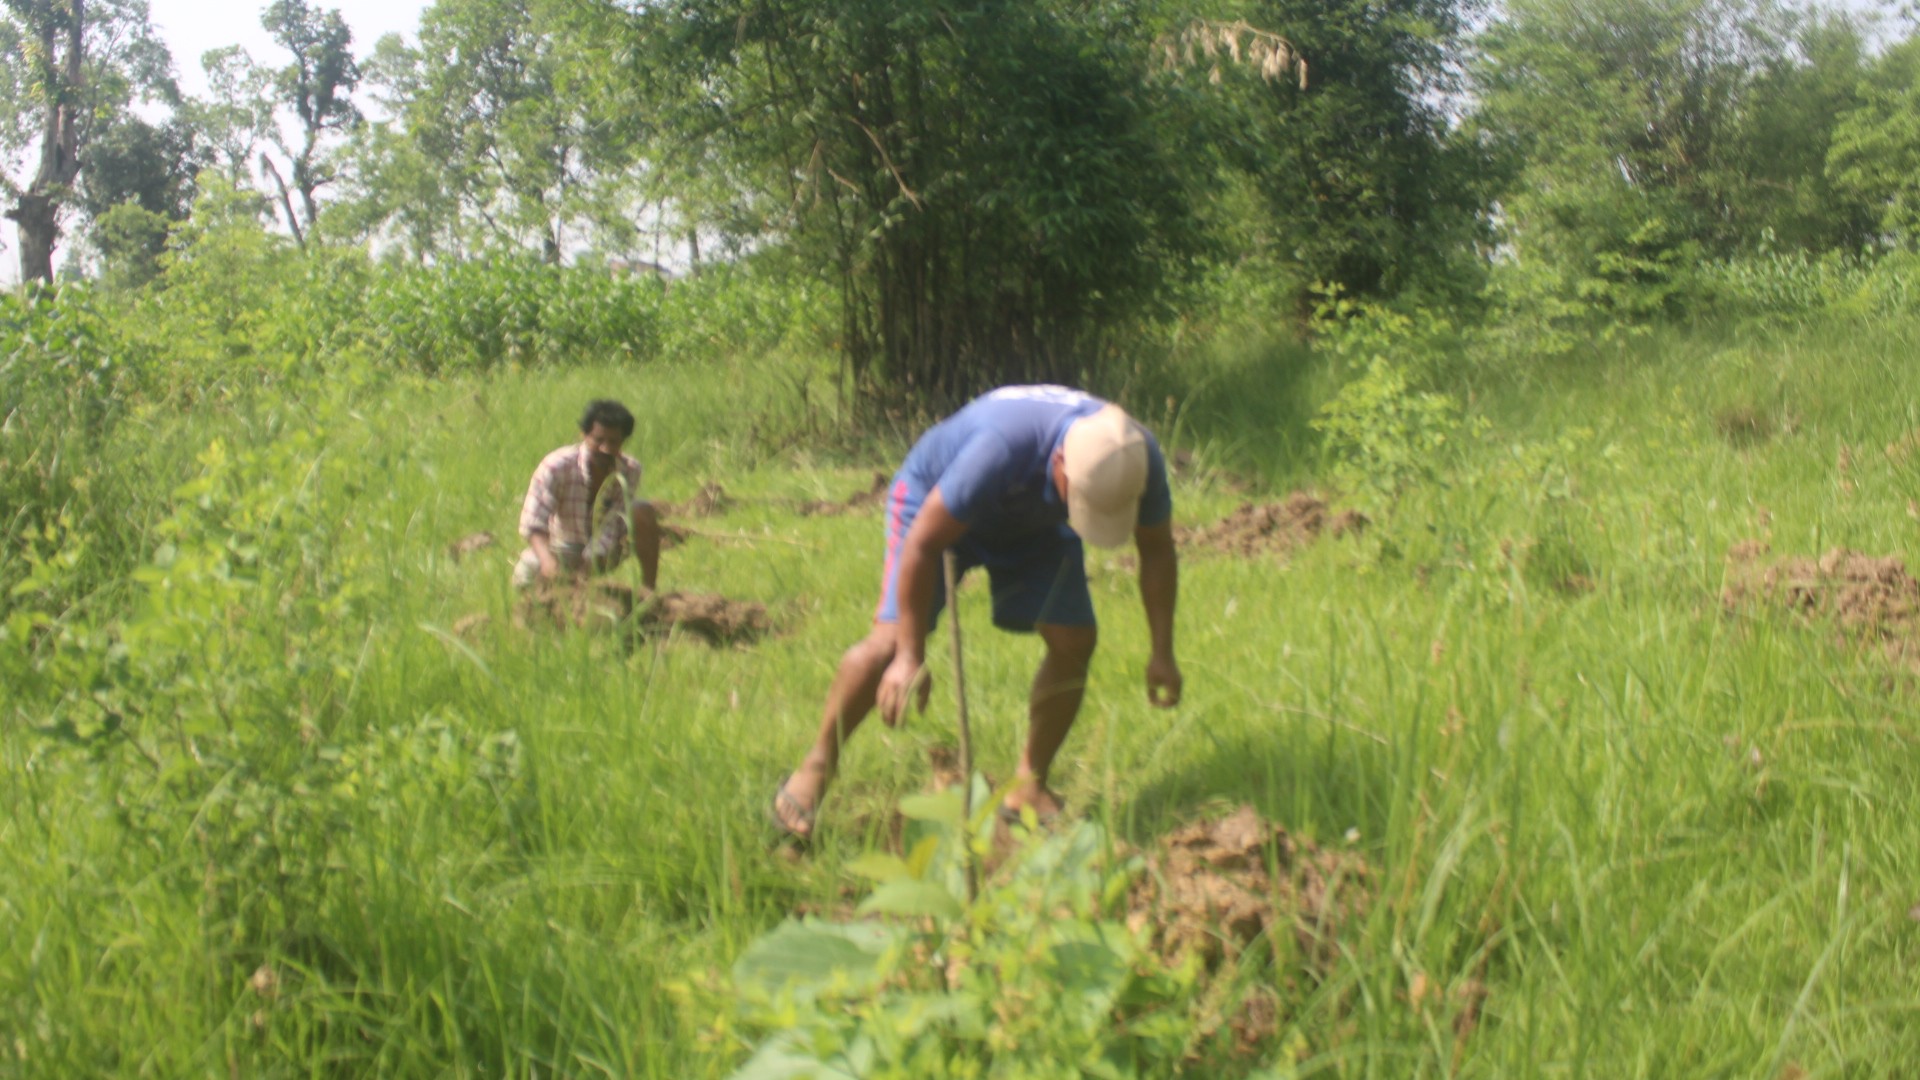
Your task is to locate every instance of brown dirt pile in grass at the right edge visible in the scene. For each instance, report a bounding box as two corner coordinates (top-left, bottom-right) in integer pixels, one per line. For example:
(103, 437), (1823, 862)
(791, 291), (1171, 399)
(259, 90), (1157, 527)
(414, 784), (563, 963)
(1720, 540), (1920, 663)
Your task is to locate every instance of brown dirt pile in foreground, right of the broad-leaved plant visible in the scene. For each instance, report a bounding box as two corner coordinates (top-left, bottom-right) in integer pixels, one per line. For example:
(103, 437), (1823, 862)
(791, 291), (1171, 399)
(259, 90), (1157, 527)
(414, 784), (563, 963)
(1127, 807), (1373, 965)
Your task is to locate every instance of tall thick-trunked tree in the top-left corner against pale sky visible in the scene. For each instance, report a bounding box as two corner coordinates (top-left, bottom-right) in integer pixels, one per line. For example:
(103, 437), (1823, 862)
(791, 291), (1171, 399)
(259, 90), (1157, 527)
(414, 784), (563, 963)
(0, 0), (179, 281)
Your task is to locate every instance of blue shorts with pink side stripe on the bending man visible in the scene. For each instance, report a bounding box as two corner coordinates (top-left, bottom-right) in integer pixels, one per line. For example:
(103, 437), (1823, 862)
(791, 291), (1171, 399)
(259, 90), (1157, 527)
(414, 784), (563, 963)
(874, 477), (1094, 632)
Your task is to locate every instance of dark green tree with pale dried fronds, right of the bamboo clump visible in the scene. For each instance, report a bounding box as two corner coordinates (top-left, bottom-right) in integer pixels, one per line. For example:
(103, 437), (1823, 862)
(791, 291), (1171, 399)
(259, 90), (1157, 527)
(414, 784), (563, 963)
(1162, 0), (1501, 315)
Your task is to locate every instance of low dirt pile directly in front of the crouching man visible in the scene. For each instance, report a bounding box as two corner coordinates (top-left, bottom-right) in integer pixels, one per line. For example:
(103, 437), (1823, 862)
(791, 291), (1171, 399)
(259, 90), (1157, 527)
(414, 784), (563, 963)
(515, 582), (774, 646)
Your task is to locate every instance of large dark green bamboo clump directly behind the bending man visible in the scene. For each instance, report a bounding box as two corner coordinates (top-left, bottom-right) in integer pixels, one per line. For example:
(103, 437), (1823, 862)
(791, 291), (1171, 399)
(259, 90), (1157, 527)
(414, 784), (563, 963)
(601, 0), (1192, 398)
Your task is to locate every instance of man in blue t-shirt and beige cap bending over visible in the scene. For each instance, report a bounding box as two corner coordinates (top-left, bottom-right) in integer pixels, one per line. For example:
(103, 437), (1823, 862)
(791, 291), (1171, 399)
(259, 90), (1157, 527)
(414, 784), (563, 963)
(772, 386), (1181, 840)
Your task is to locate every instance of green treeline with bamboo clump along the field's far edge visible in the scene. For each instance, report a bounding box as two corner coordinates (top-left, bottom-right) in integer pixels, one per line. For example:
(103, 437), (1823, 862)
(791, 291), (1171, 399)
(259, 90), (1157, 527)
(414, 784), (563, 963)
(0, 0), (1916, 390)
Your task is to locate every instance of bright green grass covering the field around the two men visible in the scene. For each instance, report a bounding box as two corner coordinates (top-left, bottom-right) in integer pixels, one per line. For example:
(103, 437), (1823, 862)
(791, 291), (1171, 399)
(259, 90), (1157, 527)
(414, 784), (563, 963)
(0, 315), (1920, 1080)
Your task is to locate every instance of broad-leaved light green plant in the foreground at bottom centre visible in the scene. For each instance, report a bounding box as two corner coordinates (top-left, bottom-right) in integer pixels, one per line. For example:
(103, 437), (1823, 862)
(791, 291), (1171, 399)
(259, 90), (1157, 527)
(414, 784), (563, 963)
(698, 780), (1298, 1080)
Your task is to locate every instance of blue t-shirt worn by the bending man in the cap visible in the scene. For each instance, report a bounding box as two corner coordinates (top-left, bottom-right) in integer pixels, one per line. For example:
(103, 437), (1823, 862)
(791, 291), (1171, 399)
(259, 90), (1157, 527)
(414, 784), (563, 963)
(900, 386), (1173, 546)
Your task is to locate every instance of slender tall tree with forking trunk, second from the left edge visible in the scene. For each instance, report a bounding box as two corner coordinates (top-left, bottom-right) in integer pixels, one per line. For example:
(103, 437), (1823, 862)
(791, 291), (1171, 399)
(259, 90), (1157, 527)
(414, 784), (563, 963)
(259, 0), (361, 244)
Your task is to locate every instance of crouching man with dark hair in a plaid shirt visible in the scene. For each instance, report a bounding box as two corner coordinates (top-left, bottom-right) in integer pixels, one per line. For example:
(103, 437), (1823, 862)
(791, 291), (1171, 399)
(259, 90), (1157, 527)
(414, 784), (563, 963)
(513, 400), (660, 590)
